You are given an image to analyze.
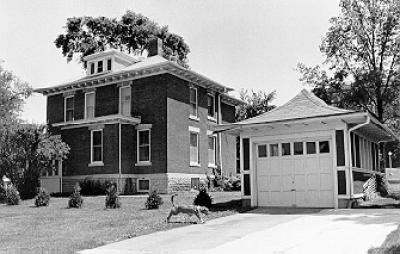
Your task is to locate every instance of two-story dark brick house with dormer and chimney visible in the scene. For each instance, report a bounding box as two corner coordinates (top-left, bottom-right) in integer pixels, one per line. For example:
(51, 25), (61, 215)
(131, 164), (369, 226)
(36, 40), (242, 193)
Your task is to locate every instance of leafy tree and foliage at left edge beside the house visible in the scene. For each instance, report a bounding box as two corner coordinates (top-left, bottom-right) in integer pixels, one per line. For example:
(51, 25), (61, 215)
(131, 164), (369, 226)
(0, 64), (69, 198)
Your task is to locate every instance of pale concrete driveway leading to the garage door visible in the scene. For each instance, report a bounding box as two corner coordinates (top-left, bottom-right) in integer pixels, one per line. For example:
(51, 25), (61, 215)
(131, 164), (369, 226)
(80, 209), (400, 254)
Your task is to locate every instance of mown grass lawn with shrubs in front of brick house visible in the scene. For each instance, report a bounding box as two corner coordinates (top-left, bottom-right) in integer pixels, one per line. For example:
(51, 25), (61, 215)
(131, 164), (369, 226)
(0, 192), (241, 253)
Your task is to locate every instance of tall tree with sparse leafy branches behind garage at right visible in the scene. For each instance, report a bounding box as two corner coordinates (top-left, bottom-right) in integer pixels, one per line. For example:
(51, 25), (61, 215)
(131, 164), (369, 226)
(298, 0), (400, 123)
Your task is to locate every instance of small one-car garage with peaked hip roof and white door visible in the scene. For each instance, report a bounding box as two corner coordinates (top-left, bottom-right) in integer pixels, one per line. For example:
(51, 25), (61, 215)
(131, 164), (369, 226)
(217, 90), (396, 208)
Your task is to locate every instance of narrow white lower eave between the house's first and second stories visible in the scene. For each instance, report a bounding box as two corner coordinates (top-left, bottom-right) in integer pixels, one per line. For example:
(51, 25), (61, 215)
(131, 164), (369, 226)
(52, 114), (141, 129)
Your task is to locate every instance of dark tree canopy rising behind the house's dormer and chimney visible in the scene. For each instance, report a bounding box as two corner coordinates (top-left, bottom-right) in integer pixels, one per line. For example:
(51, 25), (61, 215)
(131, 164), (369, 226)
(54, 11), (190, 68)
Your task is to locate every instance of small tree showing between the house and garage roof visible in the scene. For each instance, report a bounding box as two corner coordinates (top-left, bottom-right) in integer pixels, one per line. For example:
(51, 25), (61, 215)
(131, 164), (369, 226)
(235, 88), (276, 121)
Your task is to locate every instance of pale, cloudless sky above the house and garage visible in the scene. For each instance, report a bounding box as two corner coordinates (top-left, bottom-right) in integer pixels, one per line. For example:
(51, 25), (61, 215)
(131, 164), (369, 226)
(0, 0), (339, 123)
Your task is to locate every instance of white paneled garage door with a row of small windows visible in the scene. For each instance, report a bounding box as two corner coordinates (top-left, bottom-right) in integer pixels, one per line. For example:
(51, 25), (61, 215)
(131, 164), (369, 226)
(256, 139), (334, 207)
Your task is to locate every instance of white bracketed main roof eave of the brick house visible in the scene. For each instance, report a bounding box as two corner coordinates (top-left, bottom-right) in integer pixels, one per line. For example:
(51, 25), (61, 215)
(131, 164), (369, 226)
(34, 61), (233, 95)
